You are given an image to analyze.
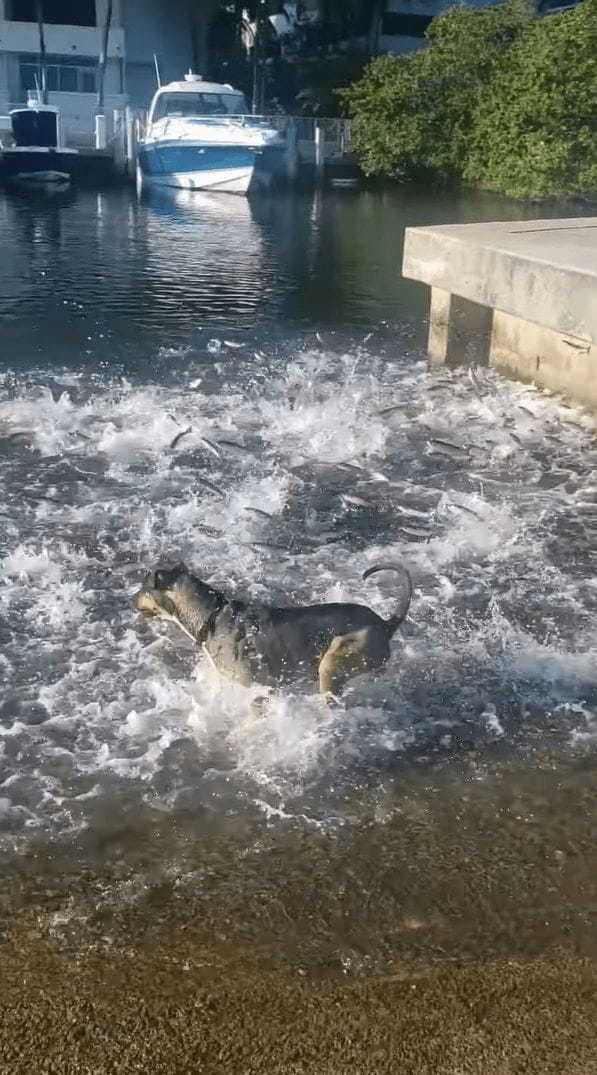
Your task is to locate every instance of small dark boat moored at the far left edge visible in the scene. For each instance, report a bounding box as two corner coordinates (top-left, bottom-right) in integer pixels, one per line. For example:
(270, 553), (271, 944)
(0, 104), (77, 190)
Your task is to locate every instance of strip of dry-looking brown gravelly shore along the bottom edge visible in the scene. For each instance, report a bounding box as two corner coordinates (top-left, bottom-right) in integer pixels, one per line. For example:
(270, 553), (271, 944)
(0, 923), (597, 1075)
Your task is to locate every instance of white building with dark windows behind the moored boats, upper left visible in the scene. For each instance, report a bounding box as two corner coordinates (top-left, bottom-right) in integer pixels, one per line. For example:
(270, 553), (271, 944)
(0, 0), (204, 145)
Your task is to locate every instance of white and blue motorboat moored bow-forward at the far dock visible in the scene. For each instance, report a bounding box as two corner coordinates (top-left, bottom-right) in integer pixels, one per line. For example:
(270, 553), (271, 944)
(138, 71), (286, 195)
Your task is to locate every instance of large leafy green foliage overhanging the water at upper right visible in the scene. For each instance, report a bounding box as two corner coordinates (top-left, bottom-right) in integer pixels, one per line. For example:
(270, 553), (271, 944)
(342, 0), (597, 197)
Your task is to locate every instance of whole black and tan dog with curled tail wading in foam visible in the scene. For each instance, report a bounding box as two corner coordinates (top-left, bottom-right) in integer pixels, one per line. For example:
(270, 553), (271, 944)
(134, 563), (412, 697)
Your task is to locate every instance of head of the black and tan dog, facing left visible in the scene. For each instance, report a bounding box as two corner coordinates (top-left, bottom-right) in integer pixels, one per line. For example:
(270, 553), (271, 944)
(133, 563), (223, 639)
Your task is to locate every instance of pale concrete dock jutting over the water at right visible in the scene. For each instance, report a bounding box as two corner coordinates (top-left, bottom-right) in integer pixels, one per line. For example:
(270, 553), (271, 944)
(402, 217), (597, 407)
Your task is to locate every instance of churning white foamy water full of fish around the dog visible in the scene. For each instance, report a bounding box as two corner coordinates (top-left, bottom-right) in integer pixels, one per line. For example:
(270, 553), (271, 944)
(0, 345), (597, 833)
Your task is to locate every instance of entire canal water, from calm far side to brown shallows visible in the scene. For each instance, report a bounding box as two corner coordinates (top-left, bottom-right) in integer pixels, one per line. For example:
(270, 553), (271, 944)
(0, 190), (597, 974)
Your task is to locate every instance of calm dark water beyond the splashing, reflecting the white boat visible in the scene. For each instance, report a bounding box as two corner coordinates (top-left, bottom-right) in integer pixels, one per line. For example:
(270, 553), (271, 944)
(0, 182), (589, 372)
